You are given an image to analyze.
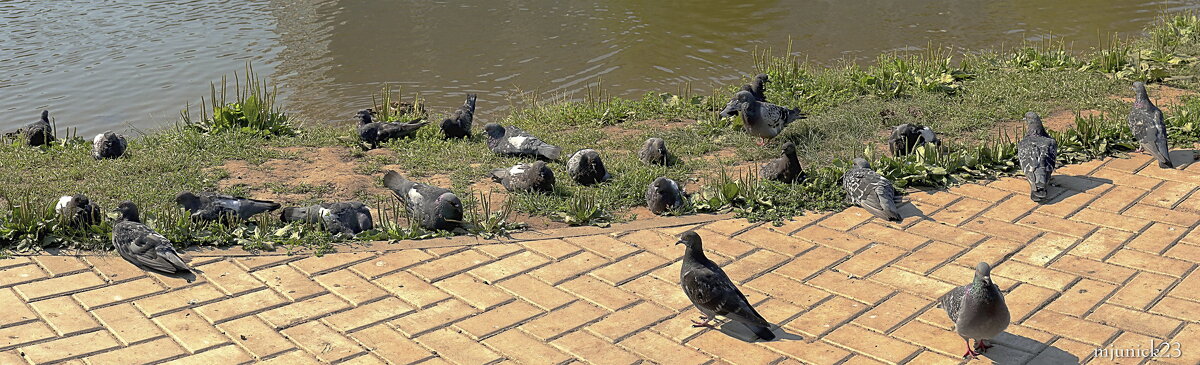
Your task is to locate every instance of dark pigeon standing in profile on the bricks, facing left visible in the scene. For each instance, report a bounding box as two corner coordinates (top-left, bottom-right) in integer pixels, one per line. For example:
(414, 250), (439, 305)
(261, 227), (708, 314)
(676, 231), (775, 341)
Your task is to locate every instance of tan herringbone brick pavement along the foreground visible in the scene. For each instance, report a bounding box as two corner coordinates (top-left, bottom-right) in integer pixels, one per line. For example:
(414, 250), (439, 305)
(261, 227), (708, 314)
(0, 152), (1200, 364)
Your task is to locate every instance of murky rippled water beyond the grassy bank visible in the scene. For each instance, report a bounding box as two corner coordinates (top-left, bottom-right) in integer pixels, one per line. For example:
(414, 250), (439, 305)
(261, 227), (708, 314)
(0, 0), (1200, 134)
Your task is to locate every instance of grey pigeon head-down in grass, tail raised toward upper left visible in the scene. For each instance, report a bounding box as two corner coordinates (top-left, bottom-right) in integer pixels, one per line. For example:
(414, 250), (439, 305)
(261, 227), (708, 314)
(383, 170), (462, 231)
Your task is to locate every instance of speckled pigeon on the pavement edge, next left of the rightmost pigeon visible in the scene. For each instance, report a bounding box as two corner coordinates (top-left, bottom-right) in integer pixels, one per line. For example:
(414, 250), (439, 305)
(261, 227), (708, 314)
(1016, 112), (1058, 202)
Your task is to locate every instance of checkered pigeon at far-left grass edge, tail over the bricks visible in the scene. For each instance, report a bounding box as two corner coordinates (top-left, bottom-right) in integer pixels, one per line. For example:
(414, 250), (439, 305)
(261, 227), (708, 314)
(113, 201), (192, 274)
